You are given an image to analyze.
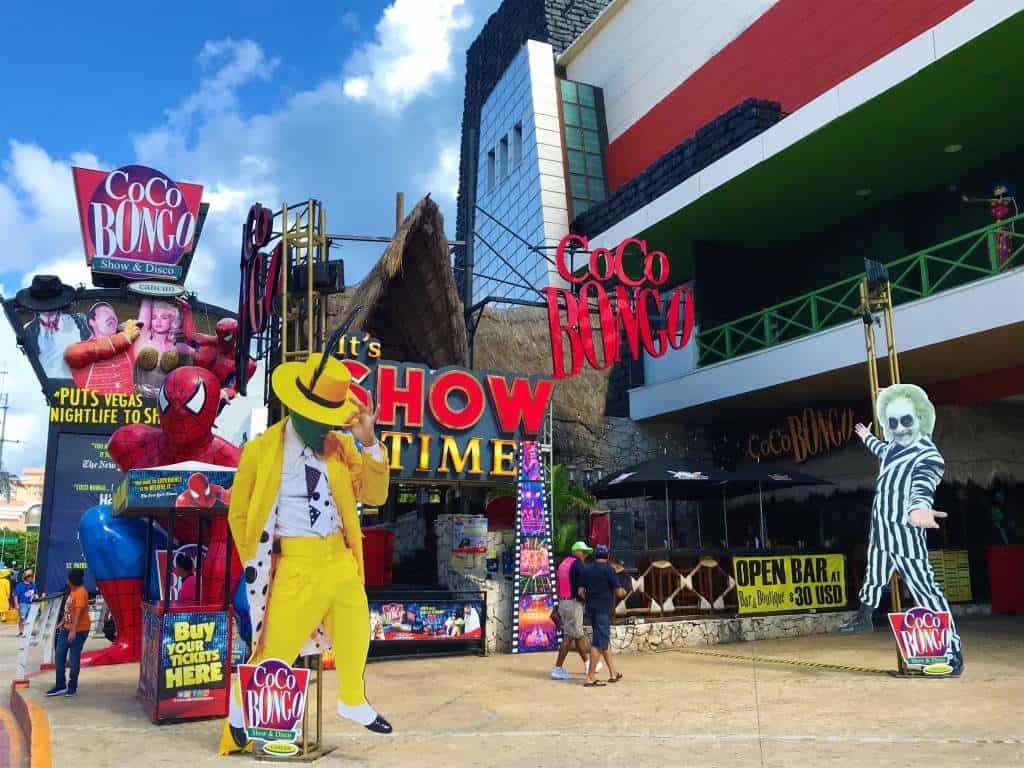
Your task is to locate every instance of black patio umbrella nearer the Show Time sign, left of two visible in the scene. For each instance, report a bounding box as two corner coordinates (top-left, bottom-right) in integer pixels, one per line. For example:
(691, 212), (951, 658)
(590, 456), (729, 546)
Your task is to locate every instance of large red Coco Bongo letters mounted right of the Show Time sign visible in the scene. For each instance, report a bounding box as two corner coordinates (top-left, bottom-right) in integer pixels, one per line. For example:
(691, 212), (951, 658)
(544, 234), (694, 379)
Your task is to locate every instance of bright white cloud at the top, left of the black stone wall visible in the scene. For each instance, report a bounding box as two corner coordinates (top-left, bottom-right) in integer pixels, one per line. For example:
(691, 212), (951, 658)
(345, 0), (472, 112)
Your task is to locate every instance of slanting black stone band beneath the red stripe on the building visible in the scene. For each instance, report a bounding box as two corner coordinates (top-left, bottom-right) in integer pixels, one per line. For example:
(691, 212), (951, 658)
(569, 98), (782, 238)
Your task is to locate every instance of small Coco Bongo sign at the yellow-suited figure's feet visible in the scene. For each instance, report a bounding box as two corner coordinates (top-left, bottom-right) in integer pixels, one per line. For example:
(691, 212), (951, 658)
(239, 658), (309, 757)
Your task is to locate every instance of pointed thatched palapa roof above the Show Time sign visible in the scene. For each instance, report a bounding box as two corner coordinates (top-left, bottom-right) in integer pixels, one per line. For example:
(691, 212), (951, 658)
(328, 196), (466, 368)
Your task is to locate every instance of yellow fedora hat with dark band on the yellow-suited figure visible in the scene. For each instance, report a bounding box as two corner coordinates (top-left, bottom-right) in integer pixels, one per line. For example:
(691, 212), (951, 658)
(270, 352), (359, 427)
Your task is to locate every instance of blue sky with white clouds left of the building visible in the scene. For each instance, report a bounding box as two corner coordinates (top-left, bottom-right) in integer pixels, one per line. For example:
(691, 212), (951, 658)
(0, 0), (499, 472)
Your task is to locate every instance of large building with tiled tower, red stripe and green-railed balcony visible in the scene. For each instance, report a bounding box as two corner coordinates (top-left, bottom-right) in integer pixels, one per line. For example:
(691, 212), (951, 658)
(457, 0), (1024, 589)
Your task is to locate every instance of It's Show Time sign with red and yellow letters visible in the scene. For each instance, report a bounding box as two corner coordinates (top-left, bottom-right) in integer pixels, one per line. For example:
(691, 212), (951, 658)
(340, 336), (553, 481)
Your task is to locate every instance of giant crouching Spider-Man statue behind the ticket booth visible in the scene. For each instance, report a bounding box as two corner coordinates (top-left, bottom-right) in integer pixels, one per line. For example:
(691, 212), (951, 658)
(79, 366), (242, 667)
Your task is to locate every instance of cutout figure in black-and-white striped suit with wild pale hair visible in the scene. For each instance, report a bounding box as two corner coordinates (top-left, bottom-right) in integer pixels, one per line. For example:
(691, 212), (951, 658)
(839, 384), (964, 675)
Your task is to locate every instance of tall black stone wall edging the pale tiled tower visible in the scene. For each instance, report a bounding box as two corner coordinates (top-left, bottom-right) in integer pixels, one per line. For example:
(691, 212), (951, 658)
(455, 0), (610, 295)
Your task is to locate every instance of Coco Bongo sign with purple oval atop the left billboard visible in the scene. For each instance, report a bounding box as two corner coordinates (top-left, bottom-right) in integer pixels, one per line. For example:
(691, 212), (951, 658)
(72, 165), (203, 282)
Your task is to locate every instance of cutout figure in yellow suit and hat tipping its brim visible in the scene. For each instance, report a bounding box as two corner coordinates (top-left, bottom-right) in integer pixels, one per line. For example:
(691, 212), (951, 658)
(221, 346), (391, 754)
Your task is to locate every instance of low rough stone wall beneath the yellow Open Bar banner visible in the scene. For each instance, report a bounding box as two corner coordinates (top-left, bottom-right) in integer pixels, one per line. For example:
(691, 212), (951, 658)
(606, 611), (854, 653)
